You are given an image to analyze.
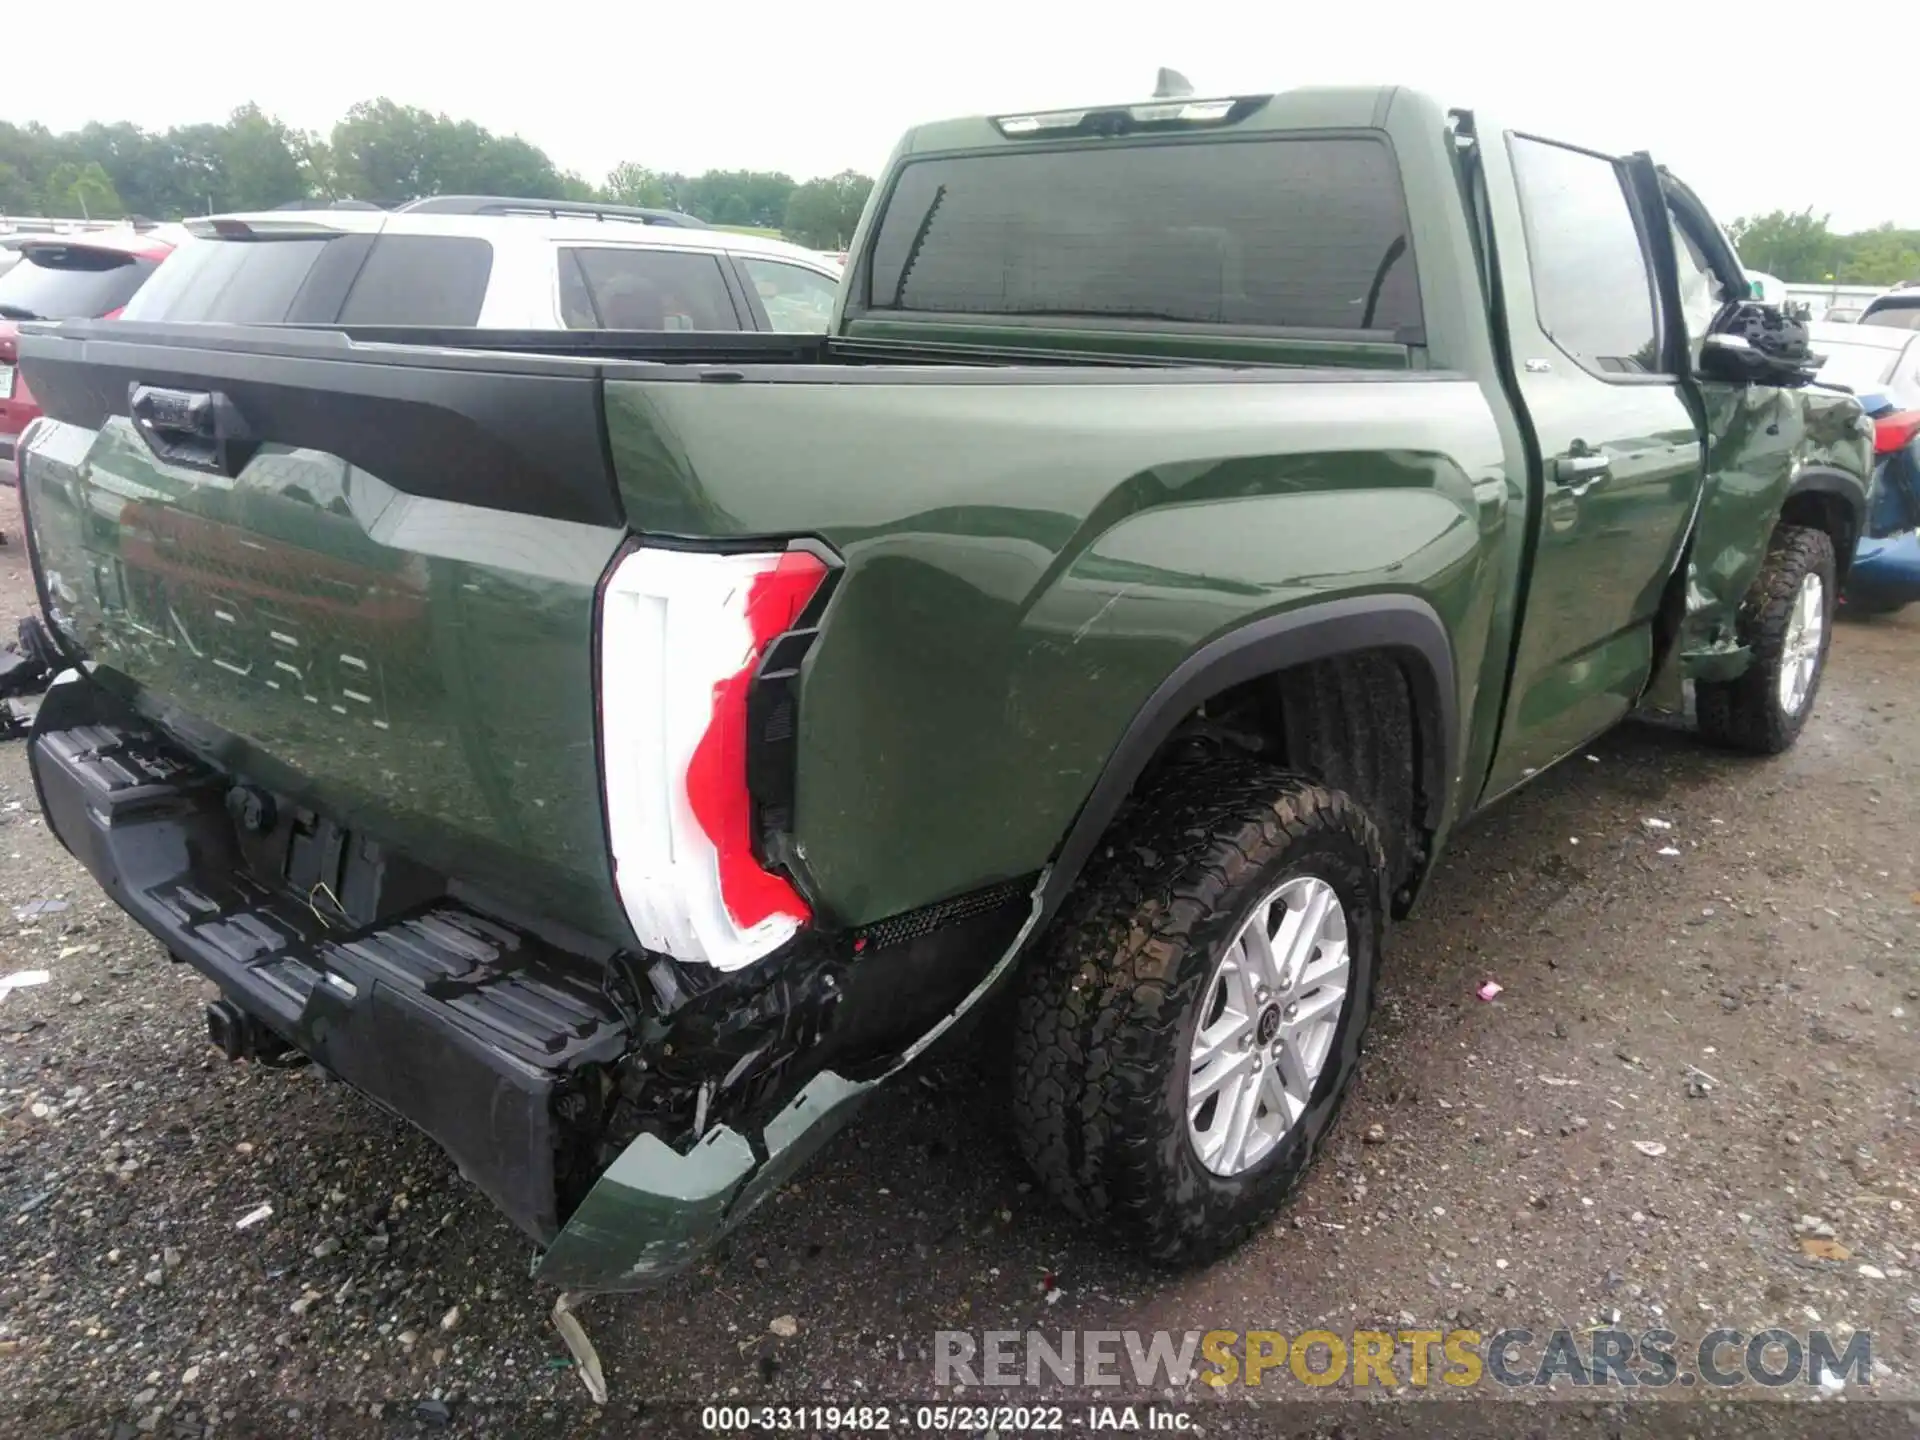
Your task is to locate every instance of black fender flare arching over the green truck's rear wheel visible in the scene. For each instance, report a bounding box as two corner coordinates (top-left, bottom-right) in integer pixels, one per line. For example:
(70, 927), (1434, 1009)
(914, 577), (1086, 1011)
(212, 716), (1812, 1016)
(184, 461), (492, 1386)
(1041, 595), (1459, 924)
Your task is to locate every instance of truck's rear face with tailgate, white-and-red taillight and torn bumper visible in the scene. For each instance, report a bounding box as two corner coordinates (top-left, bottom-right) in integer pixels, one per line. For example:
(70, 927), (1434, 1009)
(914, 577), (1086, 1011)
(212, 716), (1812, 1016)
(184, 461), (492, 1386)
(23, 324), (1059, 1288)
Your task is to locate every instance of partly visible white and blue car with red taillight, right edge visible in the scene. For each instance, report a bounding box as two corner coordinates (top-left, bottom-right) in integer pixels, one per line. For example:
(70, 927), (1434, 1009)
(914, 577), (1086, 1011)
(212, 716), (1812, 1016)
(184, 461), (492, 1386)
(1807, 324), (1920, 614)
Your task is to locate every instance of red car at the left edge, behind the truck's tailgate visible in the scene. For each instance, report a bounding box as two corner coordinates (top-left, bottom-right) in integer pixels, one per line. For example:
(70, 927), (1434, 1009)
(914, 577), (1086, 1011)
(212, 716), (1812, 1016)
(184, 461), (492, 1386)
(0, 230), (173, 470)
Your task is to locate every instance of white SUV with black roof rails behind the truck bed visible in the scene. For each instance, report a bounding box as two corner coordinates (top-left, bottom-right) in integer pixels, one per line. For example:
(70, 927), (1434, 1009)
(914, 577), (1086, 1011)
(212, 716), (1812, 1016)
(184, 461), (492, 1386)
(123, 196), (841, 334)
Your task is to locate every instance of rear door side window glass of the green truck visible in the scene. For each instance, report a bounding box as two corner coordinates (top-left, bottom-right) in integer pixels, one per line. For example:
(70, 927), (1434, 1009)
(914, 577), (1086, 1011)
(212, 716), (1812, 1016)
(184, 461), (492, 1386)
(1509, 134), (1661, 378)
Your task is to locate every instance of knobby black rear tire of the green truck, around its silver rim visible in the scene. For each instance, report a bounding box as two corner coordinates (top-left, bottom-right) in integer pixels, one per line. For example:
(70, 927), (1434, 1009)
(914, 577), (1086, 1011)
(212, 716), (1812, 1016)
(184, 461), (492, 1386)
(1010, 755), (1388, 1263)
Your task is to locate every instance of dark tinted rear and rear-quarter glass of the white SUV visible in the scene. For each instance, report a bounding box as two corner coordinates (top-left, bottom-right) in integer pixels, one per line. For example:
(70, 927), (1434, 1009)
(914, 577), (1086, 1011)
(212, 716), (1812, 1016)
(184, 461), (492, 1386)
(125, 227), (493, 326)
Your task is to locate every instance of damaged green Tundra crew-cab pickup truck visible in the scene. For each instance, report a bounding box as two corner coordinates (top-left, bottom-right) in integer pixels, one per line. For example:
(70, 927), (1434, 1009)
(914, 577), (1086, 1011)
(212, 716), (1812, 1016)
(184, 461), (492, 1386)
(7, 88), (1896, 1290)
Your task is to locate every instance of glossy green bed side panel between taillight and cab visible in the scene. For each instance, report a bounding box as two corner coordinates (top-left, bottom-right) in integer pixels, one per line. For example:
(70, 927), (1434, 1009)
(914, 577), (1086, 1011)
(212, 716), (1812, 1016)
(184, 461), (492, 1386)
(607, 372), (1517, 924)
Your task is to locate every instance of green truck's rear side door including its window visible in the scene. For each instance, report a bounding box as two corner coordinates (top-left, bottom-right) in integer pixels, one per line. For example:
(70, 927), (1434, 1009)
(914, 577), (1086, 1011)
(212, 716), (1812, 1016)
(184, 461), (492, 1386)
(1482, 132), (1703, 799)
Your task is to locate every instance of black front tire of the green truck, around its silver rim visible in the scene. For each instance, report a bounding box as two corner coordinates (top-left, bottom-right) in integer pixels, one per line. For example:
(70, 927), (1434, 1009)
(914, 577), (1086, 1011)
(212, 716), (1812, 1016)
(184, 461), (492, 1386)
(1695, 524), (1839, 755)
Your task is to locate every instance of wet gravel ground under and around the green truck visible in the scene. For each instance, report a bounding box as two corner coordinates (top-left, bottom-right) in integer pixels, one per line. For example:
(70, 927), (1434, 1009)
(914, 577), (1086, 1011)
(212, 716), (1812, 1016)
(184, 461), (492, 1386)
(0, 488), (1920, 1436)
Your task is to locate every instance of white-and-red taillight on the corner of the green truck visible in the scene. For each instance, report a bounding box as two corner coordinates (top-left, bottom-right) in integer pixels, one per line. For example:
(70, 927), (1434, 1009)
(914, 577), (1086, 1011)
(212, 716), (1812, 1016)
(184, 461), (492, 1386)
(599, 547), (826, 970)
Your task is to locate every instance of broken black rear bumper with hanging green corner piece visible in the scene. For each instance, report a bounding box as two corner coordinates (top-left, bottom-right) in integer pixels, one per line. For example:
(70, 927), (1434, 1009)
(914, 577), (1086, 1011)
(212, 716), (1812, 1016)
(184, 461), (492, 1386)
(29, 672), (1039, 1290)
